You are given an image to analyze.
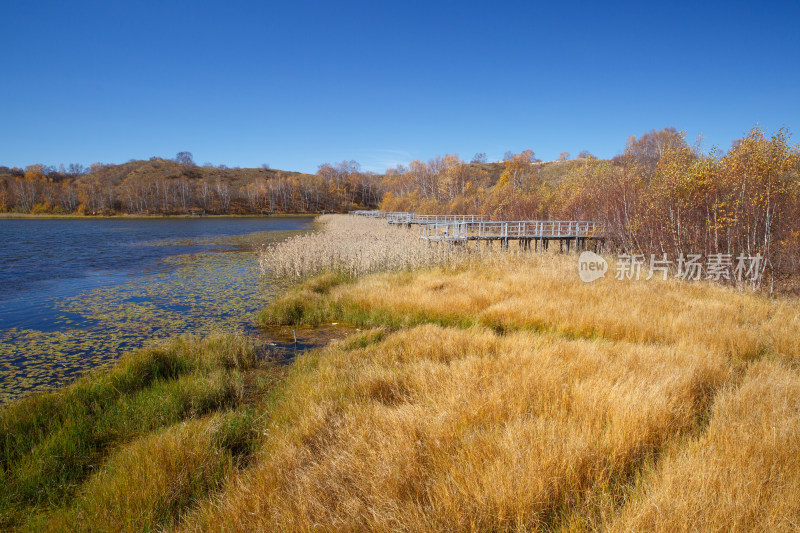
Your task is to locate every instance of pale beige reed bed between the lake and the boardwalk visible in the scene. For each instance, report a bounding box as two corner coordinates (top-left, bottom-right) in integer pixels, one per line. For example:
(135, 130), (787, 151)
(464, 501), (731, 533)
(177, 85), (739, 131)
(259, 215), (473, 282)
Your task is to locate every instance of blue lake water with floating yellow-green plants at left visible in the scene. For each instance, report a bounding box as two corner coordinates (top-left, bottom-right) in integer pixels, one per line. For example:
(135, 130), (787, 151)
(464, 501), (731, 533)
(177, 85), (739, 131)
(0, 217), (313, 401)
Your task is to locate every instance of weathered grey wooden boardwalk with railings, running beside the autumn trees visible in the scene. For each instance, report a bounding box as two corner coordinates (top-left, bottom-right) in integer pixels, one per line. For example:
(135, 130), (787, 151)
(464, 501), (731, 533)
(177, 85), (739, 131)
(350, 211), (603, 251)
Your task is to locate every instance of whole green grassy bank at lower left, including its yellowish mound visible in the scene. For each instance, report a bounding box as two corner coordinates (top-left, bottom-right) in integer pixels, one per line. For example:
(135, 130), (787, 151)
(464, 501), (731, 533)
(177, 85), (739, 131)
(0, 334), (271, 531)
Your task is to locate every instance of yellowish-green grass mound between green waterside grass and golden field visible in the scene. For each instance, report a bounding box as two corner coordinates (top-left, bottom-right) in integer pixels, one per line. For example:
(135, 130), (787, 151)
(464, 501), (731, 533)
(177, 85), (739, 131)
(37, 411), (256, 532)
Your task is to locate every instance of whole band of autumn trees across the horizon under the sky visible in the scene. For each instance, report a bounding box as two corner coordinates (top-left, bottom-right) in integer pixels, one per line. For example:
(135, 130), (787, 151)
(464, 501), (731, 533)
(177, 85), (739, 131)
(0, 128), (800, 286)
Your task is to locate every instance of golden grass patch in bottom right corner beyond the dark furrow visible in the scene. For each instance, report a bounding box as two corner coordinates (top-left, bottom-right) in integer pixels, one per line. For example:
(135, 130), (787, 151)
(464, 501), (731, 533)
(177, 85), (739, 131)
(612, 362), (800, 532)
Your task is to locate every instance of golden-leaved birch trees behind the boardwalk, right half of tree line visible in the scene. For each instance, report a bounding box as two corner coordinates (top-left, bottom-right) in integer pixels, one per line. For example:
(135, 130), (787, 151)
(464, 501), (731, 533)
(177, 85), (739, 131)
(381, 128), (800, 288)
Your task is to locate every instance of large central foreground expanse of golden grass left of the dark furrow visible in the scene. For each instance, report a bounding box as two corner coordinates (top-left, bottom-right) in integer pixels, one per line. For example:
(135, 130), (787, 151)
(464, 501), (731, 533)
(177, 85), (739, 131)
(180, 325), (730, 531)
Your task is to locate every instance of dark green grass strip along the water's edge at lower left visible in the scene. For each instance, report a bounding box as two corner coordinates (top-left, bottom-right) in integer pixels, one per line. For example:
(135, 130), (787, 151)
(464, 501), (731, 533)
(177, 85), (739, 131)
(0, 334), (257, 526)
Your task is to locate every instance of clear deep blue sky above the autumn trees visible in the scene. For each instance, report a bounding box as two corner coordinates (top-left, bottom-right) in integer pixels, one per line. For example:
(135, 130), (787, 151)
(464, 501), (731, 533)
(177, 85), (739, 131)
(0, 0), (800, 172)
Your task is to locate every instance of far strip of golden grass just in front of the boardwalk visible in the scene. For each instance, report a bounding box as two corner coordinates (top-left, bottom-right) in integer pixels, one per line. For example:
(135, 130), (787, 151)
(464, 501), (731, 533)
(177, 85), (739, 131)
(288, 253), (800, 360)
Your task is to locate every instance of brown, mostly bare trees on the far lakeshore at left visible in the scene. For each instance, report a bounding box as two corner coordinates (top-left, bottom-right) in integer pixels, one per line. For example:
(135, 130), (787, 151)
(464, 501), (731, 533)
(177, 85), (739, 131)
(0, 152), (383, 215)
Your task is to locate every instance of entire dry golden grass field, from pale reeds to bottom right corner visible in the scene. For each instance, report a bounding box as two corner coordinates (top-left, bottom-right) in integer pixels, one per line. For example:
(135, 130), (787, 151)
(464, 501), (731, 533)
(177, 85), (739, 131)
(192, 217), (800, 531)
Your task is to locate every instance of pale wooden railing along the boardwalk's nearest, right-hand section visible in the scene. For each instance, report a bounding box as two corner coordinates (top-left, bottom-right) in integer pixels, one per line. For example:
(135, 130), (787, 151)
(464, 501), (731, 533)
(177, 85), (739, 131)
(419, 220), (602, 241)
